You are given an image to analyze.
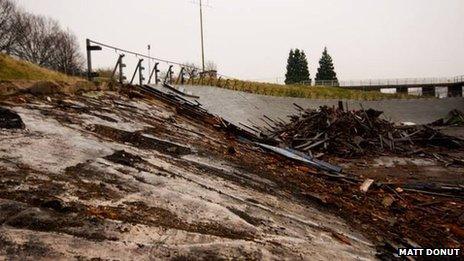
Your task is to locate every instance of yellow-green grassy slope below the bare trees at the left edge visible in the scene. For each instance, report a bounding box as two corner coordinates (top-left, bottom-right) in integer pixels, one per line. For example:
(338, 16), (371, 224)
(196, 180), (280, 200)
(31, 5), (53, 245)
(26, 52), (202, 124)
(0, 53), (82, 83)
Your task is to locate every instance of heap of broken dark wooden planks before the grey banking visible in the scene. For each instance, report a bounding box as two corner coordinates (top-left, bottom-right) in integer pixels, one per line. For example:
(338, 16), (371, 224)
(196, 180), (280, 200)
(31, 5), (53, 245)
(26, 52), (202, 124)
(262, 105), (464, 158)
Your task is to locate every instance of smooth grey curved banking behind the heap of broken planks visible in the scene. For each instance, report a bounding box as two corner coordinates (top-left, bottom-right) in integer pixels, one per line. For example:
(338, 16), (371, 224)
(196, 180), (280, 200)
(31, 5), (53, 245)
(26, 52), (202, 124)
(173, 85), (464, 126)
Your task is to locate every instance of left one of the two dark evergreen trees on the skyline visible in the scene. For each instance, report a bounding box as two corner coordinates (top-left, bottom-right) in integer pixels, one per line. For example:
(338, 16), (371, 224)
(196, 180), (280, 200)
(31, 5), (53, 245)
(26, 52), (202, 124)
(285, 49), (309, 84)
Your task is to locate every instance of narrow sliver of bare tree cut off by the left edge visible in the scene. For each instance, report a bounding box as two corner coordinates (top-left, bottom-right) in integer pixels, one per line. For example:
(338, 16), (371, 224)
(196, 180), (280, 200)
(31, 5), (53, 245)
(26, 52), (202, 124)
(0, 0), (17, 53)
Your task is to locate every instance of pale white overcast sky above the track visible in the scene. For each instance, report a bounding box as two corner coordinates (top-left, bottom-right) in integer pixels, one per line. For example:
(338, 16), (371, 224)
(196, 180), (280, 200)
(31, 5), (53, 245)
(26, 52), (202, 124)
(16, 0), (464, 81)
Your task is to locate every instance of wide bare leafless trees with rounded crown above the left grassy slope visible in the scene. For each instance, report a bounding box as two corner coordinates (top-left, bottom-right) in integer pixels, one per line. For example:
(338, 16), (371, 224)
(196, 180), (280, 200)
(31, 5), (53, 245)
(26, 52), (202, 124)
(0, 4), (83, 74)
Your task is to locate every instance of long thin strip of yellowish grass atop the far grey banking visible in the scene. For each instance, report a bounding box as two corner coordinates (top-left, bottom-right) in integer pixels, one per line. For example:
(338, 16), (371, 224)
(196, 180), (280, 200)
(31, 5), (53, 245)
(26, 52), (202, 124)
(188, 79), (420, 100)
